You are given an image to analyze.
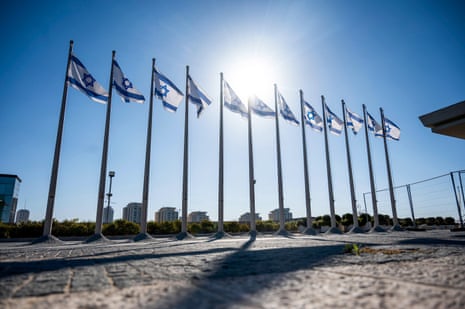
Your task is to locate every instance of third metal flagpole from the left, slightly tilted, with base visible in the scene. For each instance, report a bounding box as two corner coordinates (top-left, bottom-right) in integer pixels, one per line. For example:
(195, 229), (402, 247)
(134, 58), (155, 241)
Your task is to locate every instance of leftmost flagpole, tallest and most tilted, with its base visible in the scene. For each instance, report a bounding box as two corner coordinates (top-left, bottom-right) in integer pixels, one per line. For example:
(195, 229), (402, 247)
(34, 40), (74, 243)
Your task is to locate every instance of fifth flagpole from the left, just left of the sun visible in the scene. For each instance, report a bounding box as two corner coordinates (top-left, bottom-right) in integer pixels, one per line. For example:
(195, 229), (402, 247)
(214, 72), (225, 238)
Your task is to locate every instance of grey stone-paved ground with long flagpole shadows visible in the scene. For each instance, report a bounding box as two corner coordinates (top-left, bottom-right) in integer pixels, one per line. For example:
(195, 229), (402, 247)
(0, 230), (465, 309)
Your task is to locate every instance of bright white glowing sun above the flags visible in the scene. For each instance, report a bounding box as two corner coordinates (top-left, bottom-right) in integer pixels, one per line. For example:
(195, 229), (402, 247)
(225, 57), (275, 103)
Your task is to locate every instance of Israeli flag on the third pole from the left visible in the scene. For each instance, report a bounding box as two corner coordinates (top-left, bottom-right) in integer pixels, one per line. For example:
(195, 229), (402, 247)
(153, 67), (184, 112)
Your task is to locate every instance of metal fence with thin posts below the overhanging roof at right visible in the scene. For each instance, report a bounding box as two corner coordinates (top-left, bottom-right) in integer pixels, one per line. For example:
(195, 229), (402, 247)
(361, 170), (465, 226)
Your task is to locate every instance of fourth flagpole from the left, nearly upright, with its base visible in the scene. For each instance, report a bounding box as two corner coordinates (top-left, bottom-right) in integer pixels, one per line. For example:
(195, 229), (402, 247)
(176, 65), (191, 240)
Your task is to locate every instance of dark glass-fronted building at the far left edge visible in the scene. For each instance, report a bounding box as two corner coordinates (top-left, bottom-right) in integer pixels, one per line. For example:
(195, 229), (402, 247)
(0, 174), (21, 223)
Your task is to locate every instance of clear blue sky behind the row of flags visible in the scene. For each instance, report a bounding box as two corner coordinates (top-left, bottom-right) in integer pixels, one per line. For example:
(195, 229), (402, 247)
(0, 0), (465, 221)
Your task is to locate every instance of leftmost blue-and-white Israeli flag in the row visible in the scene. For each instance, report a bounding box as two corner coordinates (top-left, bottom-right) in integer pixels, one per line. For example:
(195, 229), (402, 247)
(67, 55), (108, 104)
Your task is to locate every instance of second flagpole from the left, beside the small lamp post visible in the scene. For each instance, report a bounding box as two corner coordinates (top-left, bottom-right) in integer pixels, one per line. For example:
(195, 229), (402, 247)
(86, 51), (116, 242)
